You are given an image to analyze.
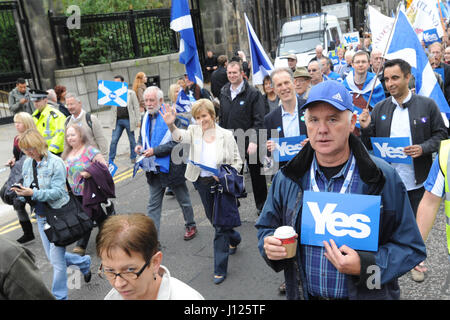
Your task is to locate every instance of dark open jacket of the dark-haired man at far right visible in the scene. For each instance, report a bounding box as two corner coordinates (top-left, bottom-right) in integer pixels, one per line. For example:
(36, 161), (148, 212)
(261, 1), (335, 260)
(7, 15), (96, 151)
(361, 93), (447, 184)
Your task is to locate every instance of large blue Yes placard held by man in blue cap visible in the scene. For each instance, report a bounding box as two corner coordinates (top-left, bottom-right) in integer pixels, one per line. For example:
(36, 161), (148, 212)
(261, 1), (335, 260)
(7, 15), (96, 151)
(300, 191), (381, 251)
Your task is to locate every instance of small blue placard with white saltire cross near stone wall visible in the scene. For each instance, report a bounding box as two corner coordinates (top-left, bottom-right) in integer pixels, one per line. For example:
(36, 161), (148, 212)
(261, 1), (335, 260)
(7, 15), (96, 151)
(97, 80), (128, 107)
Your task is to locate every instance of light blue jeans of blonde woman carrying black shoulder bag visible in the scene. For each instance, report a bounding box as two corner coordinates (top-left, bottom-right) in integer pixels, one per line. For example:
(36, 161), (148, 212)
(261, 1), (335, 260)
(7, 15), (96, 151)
(37, 216), (91, 300)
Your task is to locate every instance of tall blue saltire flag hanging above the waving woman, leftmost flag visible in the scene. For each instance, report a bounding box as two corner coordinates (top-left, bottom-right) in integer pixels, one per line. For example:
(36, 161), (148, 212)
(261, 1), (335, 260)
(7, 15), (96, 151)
(170, 0), (203, 88)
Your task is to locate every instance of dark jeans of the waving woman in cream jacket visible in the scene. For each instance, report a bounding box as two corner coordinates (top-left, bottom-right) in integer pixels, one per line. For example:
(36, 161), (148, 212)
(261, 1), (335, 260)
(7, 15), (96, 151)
(194, 180), (241, 276)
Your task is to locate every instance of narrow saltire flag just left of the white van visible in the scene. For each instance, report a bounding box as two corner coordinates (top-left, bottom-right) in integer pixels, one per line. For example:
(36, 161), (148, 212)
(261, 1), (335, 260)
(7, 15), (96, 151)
(244, 14), (274, 85)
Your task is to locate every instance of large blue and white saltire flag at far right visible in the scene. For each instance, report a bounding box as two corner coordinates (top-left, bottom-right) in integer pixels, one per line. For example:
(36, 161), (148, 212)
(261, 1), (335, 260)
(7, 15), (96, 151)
(386, 10), (450, 127)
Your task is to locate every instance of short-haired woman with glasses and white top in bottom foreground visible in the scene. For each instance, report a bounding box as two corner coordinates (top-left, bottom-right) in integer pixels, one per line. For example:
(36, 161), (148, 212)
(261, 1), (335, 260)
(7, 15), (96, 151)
(97, 213), (204, 300)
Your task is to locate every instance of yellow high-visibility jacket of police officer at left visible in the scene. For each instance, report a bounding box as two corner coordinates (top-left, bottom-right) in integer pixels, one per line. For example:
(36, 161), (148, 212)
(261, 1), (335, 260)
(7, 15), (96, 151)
(33, 104), (66, 154)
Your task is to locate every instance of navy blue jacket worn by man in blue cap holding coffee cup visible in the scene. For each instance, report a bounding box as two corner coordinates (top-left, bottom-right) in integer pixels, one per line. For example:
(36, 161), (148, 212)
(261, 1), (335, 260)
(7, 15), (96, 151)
(256, 135), (426, 300)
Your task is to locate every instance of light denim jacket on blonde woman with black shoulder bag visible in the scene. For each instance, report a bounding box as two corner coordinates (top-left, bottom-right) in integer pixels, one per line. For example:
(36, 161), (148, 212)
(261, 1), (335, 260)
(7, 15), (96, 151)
(19, 151), (70, 209)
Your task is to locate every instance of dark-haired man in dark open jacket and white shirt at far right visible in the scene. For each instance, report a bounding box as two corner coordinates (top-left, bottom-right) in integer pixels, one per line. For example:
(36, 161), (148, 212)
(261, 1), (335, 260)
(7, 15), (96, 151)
(359, 59), (447, 220)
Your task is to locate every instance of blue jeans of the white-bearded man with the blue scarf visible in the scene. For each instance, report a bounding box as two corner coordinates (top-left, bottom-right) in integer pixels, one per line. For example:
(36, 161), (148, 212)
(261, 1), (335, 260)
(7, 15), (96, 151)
(146, 172), (195, 235)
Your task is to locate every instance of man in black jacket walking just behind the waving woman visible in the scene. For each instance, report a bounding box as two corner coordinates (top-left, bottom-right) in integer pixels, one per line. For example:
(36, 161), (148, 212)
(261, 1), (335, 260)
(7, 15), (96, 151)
(219, 61), (267, 214)
